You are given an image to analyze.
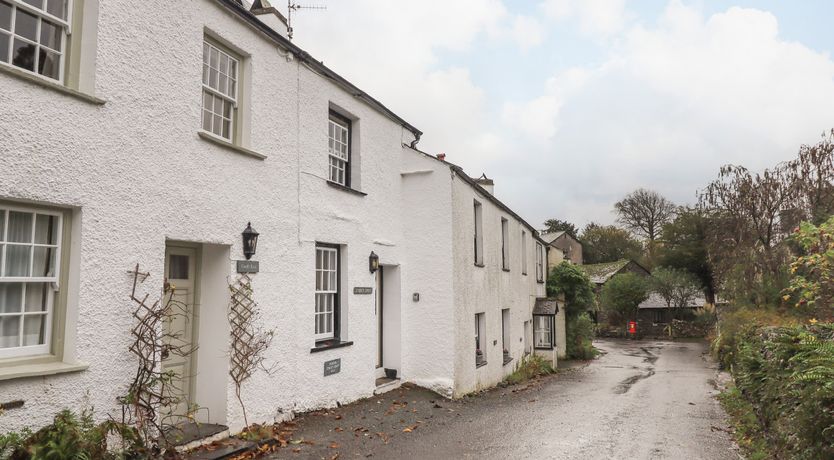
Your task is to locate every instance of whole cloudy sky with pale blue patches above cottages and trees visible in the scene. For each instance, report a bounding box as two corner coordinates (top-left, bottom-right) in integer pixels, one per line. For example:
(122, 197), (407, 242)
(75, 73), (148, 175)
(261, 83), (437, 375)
(288, 0), (834, 230)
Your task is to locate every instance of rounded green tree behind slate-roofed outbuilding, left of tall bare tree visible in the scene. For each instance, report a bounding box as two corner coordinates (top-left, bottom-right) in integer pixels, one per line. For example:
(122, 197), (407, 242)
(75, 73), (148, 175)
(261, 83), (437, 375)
(579, 222), (643, 264)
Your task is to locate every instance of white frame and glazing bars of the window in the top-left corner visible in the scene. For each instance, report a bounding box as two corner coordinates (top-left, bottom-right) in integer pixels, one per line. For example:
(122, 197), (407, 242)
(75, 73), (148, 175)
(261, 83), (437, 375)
(0, 0), (73, 84)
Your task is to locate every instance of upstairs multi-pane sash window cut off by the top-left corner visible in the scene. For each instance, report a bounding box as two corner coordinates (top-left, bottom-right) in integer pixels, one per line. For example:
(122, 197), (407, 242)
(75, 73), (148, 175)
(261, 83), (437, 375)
(0, 0), (70, 82)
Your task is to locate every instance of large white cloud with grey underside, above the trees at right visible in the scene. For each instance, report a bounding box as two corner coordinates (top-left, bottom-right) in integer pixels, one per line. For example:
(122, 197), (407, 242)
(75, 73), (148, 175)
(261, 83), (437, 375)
(504, 1), (834, 226)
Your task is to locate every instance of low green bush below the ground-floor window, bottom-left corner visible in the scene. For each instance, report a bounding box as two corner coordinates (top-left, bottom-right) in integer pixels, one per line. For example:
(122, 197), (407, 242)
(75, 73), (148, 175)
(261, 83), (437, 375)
(0, 409), (152, 460)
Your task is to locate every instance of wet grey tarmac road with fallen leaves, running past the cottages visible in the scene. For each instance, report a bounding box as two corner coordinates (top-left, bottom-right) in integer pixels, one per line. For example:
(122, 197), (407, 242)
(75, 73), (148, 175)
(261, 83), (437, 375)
(264, 340), (740, 459)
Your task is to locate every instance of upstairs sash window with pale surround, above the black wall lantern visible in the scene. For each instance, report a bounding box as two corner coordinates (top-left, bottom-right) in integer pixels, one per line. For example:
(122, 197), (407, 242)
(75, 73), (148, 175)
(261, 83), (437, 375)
(202, 41), (240, 142)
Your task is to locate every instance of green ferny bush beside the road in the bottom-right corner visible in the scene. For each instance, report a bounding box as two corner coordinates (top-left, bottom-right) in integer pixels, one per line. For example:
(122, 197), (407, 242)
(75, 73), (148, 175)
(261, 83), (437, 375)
(725, 324), (834, 459)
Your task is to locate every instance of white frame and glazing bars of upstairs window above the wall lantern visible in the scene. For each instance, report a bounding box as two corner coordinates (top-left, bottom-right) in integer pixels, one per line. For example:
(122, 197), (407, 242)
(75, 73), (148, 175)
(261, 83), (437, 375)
(200, 38), (241, 143)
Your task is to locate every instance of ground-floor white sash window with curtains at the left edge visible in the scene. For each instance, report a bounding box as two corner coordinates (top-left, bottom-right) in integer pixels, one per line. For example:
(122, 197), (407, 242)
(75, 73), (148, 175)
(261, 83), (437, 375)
(0, 204), (62, 358)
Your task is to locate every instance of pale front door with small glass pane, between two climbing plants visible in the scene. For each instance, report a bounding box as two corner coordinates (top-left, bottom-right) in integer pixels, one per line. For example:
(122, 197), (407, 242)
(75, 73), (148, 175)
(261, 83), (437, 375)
(161, 246), (197, 425)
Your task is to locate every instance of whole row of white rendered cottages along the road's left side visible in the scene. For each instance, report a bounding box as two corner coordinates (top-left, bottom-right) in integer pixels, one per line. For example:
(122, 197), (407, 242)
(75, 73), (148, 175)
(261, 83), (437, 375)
(0, 0), (544, 432)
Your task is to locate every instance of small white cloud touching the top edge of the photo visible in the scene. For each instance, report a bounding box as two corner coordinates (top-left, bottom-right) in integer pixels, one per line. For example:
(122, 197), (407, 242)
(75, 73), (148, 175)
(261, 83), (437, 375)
(541, 0), (630, 38)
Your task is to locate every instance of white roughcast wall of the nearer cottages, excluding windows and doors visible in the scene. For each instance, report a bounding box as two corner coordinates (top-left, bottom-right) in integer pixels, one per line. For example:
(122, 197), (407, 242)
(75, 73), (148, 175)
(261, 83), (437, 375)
(0, 0), (426, 431)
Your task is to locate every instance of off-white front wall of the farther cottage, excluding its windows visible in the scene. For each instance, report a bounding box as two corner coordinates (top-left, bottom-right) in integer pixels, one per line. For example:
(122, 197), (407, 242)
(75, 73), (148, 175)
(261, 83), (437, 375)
(452, 176), (545, 395)
